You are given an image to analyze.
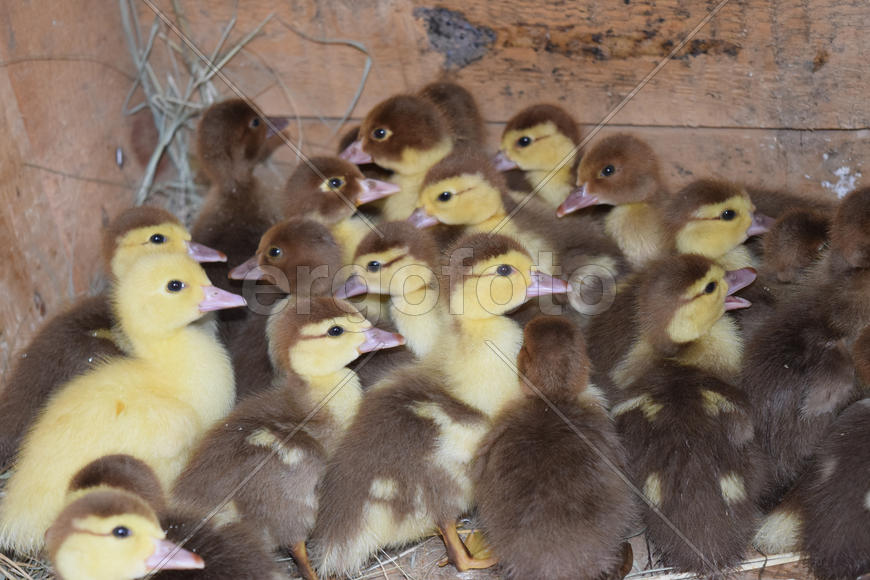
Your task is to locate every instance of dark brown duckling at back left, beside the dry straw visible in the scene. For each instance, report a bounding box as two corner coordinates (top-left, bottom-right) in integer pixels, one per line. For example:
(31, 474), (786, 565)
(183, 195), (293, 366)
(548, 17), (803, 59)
(191, 99), (287, 292)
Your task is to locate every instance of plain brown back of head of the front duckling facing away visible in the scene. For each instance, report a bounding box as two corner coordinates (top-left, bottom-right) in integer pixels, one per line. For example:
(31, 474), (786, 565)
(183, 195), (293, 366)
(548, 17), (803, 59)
(517, 316), (589, 399)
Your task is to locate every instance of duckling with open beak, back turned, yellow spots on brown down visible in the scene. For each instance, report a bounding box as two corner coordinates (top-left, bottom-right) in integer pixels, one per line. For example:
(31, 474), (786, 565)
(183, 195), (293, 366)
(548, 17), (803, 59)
(611, 254), (764, 577)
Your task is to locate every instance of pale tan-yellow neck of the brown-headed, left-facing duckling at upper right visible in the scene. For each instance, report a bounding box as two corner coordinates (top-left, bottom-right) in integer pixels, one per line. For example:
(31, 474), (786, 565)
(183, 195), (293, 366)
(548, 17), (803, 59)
(604, 201), (667, 268)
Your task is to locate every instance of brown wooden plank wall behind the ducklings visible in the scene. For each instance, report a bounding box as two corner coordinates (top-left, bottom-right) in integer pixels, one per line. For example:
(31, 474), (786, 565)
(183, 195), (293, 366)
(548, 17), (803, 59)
(0, 0), (870, 378)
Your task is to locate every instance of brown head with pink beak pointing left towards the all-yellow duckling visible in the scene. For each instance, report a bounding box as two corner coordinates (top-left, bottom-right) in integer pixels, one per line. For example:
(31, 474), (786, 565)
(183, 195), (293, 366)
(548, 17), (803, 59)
(229, 218), (341, 297)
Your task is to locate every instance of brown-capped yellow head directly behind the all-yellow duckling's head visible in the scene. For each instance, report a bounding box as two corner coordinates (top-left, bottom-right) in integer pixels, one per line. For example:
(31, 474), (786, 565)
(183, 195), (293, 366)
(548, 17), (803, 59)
(103, 206), (227, 278)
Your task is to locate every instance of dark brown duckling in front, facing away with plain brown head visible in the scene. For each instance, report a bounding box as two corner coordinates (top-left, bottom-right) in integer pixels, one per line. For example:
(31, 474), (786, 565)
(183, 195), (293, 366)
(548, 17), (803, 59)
(475, 316), (637, 580)
